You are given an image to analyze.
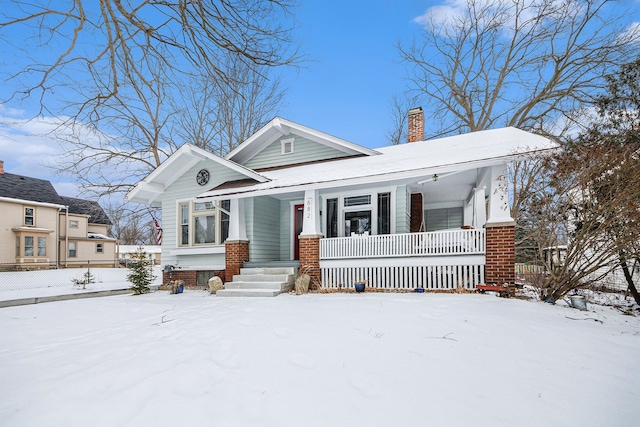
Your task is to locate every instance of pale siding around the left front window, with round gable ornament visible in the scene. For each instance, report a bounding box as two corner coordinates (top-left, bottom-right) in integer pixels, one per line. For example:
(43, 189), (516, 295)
(162, 160), (246, 267)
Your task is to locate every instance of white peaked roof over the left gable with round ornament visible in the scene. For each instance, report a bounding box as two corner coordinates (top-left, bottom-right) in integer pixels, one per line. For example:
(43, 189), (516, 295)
(127, 144), (268, 204)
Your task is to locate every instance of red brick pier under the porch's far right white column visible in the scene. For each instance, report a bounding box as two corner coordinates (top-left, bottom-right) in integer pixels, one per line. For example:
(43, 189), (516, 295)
(485, 224), (516, 285)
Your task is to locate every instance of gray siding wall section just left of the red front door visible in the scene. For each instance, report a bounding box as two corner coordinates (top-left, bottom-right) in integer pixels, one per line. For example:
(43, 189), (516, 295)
(245, 196), (280, 262)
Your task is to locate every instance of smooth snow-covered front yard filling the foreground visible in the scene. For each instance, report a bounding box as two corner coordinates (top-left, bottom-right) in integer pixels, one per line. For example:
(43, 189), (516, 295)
(0, 290), (640, 427)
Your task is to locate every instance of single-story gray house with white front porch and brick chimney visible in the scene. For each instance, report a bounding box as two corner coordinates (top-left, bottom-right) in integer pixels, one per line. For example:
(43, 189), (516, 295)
(128, 108), (556, 289)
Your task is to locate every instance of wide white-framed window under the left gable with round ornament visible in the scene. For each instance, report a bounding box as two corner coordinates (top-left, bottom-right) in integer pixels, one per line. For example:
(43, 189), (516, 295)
(179, 200), (231, 246)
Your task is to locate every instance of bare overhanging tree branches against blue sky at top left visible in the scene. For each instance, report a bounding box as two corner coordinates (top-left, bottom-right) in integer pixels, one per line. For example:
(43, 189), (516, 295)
(0, 0), (298, 121)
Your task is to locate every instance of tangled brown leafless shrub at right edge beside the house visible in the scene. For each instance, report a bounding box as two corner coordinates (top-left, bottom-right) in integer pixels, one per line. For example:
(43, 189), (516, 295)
(532, 129), (640, 303)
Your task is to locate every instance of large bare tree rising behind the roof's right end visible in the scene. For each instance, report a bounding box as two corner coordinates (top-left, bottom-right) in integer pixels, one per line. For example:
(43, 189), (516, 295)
(398, 0), (640, 137)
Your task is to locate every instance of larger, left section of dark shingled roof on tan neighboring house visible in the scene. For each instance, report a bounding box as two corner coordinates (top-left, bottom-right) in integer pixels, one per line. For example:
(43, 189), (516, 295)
(0, 172), (64, 205)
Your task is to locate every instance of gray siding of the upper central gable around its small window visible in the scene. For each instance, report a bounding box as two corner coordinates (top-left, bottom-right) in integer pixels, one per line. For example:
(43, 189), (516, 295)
(244, 136), (347, 169)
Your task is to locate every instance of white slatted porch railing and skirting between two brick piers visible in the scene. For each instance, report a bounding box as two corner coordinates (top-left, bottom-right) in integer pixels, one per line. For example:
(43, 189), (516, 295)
(320, 230), (485, 290)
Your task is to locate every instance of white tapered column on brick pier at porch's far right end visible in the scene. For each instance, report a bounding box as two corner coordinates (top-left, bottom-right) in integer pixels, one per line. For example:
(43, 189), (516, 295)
(485, 165), (516, 285)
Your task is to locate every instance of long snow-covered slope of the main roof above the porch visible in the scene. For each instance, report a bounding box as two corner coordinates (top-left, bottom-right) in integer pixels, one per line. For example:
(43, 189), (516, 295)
(199, 127), (557, 198)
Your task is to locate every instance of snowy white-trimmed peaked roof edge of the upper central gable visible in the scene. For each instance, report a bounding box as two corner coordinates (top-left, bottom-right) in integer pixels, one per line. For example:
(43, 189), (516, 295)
(225, 117), (379, 164)
